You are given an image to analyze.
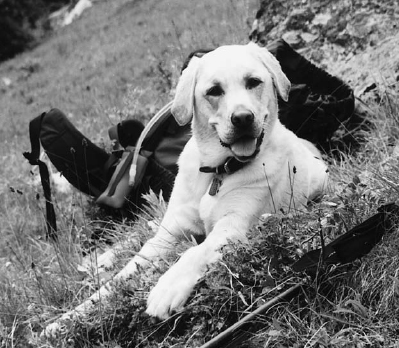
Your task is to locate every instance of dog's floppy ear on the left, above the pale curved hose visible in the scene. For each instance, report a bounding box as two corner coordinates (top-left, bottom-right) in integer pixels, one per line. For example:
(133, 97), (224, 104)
(172, 56), (200, 126)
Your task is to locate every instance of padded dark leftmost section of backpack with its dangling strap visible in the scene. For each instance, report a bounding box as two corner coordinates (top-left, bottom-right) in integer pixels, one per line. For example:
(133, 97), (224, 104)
(23, 109), (109, 239)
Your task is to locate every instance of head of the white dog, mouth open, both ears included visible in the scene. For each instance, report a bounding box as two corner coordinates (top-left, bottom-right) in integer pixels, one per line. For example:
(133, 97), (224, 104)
(172, 43), (290, 161)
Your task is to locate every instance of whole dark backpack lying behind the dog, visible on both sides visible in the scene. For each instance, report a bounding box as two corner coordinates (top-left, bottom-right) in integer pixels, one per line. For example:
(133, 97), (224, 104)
(24, 39), (358, 239)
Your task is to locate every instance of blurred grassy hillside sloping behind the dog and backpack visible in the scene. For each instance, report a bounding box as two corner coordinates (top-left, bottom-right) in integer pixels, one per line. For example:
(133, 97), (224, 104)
(0, 0), (256, 258)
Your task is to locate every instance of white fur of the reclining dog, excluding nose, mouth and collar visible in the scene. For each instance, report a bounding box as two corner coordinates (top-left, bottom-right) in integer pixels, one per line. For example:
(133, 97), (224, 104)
(43, 43), (328, 336)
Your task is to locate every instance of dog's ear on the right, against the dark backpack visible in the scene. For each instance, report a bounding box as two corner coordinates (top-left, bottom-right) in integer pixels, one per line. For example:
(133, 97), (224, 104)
(247, 42), (291, 101)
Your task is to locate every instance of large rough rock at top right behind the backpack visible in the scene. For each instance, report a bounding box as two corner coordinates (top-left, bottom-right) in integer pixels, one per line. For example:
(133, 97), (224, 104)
(252, 0), (399, 98)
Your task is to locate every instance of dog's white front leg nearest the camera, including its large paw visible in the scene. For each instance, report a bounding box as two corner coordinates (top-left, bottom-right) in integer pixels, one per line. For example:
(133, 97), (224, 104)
(146, 214), (250, 319)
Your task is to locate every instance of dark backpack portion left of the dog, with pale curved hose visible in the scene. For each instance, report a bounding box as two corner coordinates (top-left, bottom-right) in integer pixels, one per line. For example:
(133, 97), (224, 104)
(23, 103), (191, 240)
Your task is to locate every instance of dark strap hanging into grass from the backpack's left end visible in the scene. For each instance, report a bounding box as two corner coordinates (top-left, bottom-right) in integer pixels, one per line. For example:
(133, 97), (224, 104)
(23, 112), (57, 241)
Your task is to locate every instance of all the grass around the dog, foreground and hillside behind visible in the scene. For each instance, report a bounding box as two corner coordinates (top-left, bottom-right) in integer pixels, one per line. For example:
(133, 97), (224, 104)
(0, 0), (399, 347)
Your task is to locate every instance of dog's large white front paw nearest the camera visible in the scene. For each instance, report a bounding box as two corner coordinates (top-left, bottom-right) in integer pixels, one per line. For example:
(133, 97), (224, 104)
(146, 260), (201, 319)
